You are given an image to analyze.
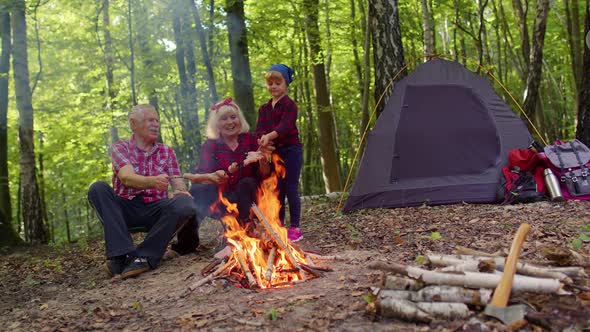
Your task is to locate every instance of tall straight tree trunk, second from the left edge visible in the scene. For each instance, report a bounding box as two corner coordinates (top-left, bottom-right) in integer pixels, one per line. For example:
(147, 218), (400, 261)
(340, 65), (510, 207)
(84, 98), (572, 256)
(11, 0), (48, 244)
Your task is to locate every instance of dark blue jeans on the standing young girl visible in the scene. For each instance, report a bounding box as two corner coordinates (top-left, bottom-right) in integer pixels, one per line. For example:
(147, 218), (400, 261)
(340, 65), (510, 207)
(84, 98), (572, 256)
(276, 145), (303, 227)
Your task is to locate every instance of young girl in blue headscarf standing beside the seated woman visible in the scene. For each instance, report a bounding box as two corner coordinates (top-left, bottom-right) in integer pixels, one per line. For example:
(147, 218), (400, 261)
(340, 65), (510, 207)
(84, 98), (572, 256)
(256, 64), (303, 242)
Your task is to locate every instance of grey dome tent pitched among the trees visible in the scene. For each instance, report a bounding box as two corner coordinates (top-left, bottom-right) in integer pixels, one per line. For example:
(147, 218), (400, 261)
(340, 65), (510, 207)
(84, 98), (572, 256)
(344, 59), (533, 212)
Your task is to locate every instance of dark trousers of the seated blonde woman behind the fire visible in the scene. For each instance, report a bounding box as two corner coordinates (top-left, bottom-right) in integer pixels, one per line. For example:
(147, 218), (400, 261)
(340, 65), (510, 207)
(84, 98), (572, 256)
(172, 177), (258, 254)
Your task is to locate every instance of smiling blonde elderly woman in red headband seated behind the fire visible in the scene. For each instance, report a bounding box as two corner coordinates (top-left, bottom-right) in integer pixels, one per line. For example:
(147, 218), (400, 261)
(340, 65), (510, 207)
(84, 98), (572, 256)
(172, 98), (270, 254)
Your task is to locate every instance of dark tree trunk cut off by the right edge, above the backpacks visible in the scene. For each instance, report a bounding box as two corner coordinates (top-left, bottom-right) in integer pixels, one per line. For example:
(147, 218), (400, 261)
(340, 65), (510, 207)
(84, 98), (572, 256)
(576, 0), (590, 146)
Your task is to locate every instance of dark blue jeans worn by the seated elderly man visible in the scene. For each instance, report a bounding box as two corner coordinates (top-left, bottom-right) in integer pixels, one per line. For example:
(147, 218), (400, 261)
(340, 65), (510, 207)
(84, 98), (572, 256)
(88, 181), (196, 268)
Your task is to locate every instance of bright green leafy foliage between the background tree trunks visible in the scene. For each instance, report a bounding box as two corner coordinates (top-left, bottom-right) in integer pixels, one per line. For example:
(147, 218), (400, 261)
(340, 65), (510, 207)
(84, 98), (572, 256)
(3, 0), (585, 242)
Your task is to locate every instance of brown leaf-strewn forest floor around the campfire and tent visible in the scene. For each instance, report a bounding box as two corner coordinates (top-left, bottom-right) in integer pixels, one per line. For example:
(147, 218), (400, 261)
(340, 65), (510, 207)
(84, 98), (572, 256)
(0, 199), (590, 331)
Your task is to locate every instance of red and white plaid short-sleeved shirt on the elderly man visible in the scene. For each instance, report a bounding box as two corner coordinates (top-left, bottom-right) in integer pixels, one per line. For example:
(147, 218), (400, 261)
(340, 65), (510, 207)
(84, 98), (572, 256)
(111, 135), (180, 203)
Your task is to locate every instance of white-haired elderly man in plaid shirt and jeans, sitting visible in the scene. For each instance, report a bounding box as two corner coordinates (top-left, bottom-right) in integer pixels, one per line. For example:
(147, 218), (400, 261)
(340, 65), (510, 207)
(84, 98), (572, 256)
(88, 105), (196, 279)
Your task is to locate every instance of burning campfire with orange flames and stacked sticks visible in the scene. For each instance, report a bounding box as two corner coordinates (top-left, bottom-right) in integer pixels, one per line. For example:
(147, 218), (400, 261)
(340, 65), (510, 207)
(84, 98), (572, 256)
(189, 155), (330, 290)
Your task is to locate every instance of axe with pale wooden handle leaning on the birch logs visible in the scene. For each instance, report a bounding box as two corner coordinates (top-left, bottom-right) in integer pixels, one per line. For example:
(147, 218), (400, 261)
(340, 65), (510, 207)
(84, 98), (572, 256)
(484, 223), (531, 324)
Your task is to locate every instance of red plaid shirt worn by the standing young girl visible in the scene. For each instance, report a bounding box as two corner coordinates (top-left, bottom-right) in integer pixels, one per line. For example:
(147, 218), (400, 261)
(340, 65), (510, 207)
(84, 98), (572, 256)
(256, 96), (301, 146)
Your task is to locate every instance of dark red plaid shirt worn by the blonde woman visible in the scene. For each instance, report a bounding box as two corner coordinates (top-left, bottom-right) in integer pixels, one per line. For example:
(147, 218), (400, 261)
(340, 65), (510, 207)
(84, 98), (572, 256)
(196, 132), (258, 189)
